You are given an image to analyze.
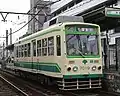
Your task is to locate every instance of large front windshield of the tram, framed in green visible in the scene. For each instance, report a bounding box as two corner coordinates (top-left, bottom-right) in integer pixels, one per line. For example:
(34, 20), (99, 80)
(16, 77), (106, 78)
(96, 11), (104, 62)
(66, 34), (99, 56)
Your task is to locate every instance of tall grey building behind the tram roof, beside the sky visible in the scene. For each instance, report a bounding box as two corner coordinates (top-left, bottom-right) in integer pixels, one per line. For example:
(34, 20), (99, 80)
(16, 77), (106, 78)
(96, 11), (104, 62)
(27, 0), (50, 34)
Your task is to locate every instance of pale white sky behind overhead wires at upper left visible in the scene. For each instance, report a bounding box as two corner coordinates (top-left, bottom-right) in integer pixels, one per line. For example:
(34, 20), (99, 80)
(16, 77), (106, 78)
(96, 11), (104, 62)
(0, 0), (30, 45)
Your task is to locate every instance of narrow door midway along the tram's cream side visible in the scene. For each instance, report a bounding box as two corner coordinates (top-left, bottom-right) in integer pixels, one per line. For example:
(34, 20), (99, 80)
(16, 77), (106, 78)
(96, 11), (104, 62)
(31, 40), (36, 69)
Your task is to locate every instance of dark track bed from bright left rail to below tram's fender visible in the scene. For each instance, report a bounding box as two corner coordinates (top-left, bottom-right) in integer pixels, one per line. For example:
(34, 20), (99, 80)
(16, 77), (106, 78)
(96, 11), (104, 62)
(0, 69), (120, 96)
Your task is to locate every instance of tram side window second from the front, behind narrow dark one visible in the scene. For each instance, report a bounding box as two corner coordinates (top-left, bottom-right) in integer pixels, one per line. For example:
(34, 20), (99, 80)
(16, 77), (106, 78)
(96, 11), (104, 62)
(48, 37), (54, 56)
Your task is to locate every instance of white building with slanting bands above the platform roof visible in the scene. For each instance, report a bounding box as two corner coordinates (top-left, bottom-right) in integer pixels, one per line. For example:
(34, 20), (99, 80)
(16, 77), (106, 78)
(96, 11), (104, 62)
(51, 0), (119, 17)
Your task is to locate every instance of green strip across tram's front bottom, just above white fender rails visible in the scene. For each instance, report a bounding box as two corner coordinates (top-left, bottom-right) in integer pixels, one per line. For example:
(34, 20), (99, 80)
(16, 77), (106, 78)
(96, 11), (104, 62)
(63, 74), (103, 79)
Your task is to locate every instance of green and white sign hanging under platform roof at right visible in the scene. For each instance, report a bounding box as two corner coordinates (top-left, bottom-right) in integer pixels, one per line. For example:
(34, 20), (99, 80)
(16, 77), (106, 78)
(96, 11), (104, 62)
(105, 8), (120, 18)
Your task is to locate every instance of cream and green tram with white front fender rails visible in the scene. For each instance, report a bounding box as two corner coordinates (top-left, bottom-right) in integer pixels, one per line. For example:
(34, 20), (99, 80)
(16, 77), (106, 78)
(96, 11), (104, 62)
(14, 22), (103, 90)
